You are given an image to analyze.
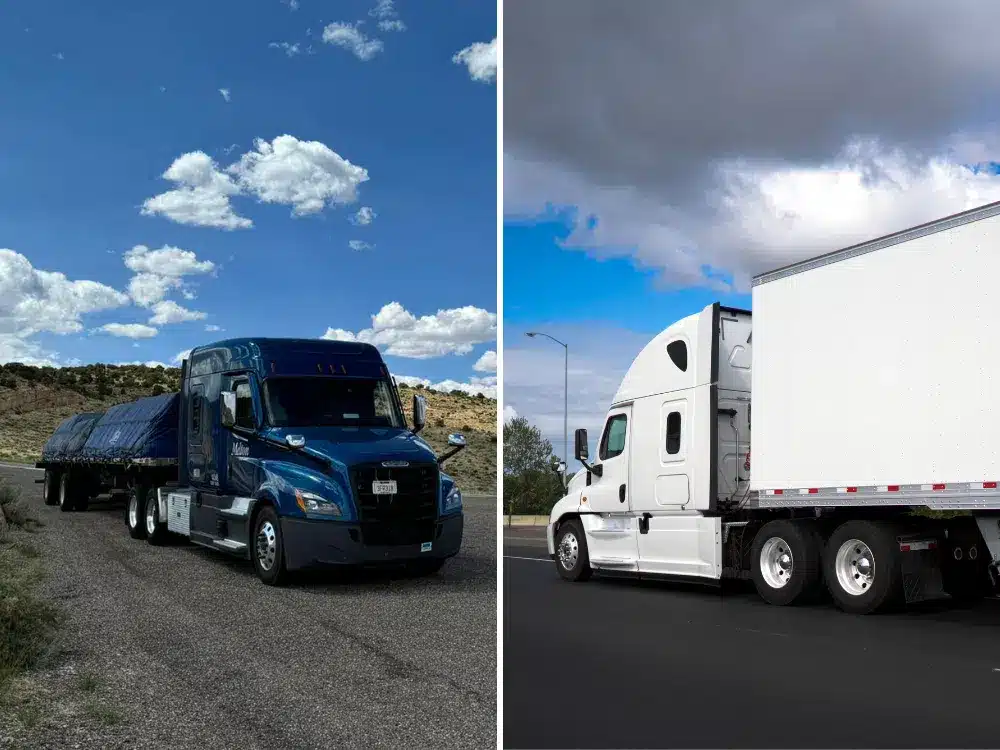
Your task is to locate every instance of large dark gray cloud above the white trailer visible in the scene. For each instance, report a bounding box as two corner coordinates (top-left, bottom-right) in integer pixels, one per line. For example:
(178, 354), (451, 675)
(503, 0), (1000, 202)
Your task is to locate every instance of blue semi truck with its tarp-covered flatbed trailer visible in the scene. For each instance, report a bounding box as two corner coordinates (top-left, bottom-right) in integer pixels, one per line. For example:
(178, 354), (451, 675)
(36, 338), (465, 585)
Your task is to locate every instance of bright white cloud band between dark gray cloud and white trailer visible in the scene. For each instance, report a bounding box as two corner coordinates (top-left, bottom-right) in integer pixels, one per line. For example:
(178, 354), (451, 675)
(504, 139), (1000, 292)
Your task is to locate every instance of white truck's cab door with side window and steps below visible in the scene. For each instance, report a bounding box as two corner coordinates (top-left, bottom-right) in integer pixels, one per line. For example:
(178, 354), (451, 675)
(581, 404), (636, 570)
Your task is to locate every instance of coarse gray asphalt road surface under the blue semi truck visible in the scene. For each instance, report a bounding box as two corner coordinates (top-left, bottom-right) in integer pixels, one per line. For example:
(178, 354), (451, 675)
(0, 467), (497, 749)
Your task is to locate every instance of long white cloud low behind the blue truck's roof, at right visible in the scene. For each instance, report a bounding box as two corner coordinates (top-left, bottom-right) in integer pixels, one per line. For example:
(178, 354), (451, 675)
(323, 302), (497, 359)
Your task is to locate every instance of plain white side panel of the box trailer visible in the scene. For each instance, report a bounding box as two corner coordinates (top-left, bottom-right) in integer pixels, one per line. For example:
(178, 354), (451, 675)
(751, 204), (1000, 491)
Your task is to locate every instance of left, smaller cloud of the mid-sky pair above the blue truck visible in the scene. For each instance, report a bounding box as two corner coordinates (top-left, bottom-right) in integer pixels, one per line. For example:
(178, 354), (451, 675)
(142, 151), (253, 230)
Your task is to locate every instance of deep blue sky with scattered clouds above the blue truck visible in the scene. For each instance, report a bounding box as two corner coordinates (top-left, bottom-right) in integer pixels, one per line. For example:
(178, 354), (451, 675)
(0, 0), (497, 396)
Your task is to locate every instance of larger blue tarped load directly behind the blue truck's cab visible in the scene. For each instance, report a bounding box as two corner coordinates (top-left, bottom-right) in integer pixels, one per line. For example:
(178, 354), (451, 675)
(80, 393), (180, 461)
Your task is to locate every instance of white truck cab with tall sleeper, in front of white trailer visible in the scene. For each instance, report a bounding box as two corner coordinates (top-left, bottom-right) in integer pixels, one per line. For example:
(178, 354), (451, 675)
(547, 304), (752, 579)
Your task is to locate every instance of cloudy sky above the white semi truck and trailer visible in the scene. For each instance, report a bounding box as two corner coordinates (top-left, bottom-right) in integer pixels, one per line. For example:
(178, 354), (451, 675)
(502, 0), (1000, 468)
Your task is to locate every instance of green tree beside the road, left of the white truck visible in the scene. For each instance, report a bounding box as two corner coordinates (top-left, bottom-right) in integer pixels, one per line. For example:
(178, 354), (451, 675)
(503, 417), (563, 514)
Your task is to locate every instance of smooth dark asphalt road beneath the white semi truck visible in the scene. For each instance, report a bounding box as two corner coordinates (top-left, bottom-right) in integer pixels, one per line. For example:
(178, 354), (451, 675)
(503, 528), (1000, 748)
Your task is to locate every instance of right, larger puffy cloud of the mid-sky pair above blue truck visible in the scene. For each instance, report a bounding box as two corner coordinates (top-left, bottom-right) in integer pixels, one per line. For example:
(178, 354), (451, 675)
(229, 135), (368, 216)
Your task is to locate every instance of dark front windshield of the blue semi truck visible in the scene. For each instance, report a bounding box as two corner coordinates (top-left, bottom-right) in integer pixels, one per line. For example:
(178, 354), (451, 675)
(264, 377), (406, 428)
